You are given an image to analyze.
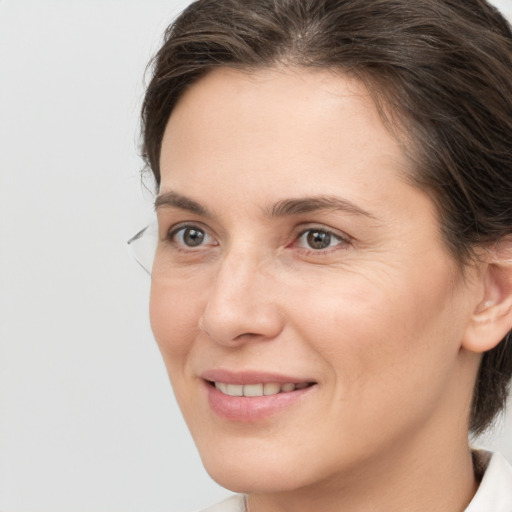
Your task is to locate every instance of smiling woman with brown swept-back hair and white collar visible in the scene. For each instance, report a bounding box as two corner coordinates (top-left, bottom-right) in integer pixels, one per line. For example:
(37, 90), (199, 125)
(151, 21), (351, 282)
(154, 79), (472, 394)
(130, 0), (512, 512)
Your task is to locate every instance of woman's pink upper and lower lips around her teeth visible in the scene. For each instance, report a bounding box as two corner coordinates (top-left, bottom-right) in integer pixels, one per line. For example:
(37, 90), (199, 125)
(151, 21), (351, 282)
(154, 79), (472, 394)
(201, 370), (317, 423)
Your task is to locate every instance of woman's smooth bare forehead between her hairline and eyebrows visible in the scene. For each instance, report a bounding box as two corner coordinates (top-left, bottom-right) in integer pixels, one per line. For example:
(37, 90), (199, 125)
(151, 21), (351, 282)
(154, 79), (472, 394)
(160, 68), (410, 196)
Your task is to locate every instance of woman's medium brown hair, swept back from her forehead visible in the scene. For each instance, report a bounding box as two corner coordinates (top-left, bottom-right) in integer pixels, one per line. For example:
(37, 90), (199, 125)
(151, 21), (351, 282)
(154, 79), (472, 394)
(142, 0), (512, 433)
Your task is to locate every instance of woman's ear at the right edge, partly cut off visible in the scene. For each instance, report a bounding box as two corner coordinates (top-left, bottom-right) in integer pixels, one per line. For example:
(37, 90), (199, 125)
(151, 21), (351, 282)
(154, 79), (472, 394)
(462, 237), (512, 353)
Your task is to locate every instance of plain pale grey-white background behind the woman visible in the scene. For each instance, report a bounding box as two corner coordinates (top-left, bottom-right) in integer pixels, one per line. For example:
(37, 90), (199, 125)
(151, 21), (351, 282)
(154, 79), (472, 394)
(0, 0), (512, 512)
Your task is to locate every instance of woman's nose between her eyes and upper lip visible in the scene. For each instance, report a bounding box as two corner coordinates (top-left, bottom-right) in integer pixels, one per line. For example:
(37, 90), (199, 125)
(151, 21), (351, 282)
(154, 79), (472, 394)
(199, 249), (283, 346)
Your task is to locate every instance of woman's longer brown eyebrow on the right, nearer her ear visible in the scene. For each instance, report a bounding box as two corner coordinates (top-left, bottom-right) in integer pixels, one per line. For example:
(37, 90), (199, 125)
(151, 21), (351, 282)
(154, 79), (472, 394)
(268, 196), (379, 220)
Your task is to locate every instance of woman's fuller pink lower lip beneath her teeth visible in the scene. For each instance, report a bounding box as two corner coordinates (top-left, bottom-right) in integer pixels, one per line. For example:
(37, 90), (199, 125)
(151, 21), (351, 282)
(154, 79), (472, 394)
(205, 381), (316, 423)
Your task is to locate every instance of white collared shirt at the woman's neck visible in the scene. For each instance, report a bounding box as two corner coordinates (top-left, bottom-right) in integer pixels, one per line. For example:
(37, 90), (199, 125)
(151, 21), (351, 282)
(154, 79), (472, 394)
(199, 452), (512, 512)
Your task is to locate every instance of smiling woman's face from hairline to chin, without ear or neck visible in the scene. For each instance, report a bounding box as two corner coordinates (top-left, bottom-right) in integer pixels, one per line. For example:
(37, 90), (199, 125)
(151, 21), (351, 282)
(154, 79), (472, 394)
(151, 68), (479, 492)
